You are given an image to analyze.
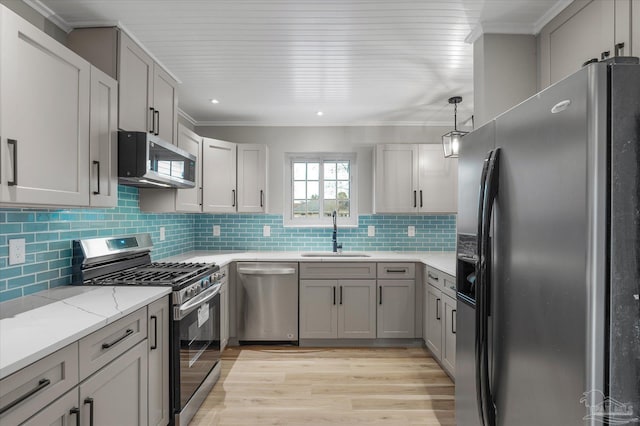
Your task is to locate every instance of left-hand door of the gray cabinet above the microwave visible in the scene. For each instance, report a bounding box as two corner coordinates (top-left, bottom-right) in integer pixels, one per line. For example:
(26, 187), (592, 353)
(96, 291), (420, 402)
(118, 31), (153, 132)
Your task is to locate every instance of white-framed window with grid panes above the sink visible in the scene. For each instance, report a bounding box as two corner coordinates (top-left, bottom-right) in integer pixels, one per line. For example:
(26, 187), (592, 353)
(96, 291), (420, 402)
(284, 153), (358, 226)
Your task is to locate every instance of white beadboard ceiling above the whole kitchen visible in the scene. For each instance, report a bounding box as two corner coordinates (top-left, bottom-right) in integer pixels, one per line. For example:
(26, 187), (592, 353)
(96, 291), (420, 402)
(32, 0), (567, 125)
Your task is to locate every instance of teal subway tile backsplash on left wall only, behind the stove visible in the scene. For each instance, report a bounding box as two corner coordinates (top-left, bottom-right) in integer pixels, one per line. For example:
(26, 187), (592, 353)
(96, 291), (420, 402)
(0, 186), (196, 301)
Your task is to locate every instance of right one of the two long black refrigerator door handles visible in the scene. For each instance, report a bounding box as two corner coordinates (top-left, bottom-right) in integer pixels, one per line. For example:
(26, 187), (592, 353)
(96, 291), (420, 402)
(476, 148), (500, 426)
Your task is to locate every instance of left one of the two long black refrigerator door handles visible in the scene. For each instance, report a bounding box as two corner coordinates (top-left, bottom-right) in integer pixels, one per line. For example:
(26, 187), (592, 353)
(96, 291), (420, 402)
(474, 151), (493, 426)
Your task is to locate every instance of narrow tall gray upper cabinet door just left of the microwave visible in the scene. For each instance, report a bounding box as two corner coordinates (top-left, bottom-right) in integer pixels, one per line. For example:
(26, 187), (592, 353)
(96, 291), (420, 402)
(89, 66), (118, 207)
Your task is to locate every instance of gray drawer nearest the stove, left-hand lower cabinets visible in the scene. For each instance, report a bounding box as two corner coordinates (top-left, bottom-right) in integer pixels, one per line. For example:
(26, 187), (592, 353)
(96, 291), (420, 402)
(80, 307), (147, 381)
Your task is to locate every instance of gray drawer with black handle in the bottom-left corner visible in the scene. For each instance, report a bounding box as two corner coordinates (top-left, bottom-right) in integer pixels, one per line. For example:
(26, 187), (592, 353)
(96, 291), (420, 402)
(0, 343), (78, 425)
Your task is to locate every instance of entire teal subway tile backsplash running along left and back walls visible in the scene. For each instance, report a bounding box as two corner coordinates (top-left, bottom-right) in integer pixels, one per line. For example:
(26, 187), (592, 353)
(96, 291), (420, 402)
(0, 186), (456, 302)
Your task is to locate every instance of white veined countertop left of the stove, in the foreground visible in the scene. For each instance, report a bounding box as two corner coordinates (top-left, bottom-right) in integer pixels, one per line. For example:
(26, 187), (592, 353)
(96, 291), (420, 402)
(0, 286), (171, 379)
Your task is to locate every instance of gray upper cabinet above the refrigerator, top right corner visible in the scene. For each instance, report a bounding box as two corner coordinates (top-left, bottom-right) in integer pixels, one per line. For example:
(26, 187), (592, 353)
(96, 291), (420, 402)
(538, 0), (640, 89)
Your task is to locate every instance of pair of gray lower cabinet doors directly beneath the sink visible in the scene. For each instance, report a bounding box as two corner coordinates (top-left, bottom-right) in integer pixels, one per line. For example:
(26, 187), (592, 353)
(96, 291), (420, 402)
(300, 279), (376, 339)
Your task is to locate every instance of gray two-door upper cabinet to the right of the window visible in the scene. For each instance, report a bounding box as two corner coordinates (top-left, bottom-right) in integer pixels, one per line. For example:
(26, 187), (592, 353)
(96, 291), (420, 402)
(374, 144), (458, 213)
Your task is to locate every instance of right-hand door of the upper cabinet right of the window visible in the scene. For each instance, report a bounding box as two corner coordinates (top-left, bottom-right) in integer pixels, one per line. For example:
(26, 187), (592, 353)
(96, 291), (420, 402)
(418, 144), (458, 213)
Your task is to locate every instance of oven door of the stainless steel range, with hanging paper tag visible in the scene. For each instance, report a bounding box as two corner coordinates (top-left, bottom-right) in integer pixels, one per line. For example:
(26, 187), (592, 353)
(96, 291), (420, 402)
(173, 284), (220, 412)
